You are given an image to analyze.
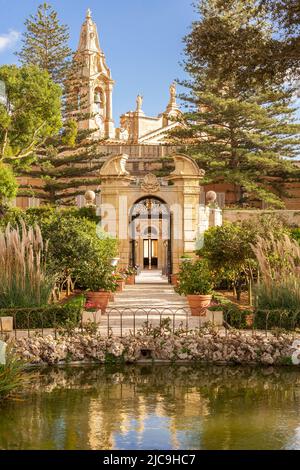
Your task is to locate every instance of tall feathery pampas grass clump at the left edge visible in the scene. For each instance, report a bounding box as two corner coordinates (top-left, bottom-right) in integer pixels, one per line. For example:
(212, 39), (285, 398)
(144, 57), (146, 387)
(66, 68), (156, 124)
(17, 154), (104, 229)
(0, 222), (54, 308)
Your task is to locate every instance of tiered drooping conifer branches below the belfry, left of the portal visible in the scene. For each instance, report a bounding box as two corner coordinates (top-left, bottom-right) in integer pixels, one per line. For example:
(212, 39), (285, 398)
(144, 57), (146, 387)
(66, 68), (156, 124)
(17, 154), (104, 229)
(19, 123), (105, 205)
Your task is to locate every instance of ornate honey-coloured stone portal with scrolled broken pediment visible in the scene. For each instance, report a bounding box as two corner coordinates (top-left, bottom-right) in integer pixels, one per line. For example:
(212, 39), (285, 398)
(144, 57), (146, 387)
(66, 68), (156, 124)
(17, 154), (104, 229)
(100, 154), (217, 274)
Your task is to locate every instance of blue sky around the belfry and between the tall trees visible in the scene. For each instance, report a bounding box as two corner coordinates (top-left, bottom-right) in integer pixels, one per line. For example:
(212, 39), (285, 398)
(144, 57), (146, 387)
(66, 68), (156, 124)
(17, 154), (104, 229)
(0, 0), (196, 125)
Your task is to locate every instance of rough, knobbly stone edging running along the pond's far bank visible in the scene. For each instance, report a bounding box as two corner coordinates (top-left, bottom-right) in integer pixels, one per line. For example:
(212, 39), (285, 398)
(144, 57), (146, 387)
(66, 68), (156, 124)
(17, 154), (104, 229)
(13, 330), (300, 365)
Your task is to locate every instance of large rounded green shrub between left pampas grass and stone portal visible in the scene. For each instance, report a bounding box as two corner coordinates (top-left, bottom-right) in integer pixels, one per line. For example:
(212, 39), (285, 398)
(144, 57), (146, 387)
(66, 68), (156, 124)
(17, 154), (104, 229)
(0, 206), (118, 289)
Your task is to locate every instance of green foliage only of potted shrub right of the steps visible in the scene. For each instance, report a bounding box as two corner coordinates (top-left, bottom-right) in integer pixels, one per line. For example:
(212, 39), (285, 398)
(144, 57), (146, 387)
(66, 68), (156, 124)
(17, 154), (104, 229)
(176, 260), (213, 295)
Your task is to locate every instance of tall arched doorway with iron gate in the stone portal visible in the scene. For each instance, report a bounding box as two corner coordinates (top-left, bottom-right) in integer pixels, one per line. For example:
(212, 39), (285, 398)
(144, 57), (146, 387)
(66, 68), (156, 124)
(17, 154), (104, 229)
(130, 196), (172, 278)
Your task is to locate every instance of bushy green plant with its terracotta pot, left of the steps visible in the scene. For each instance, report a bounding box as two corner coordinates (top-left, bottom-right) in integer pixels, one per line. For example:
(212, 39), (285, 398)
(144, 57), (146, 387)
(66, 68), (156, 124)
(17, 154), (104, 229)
(81, 263), (117, 313)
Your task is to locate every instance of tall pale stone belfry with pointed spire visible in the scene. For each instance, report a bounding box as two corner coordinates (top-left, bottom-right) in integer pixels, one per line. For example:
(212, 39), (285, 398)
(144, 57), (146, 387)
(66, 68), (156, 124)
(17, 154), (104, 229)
(74, 9), (115, 139)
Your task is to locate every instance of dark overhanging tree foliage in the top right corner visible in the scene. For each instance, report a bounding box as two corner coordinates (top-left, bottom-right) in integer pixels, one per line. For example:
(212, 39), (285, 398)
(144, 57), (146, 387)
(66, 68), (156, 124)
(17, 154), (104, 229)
(185, 0), (300, 90)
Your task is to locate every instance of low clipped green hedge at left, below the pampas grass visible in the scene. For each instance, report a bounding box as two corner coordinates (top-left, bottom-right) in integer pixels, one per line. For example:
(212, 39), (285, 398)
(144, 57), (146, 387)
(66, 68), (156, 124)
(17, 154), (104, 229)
(0, 303), (82, 329)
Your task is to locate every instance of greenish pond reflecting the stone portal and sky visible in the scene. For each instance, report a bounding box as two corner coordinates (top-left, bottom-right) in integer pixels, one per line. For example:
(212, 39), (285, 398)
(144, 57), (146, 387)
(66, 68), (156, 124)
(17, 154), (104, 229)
(0, 366), (300, 450)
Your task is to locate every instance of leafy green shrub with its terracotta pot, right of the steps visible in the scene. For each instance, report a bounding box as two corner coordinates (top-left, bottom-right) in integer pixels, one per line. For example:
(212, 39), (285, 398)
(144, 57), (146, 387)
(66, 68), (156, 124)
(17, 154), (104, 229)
(175, 260), (213, 316)
